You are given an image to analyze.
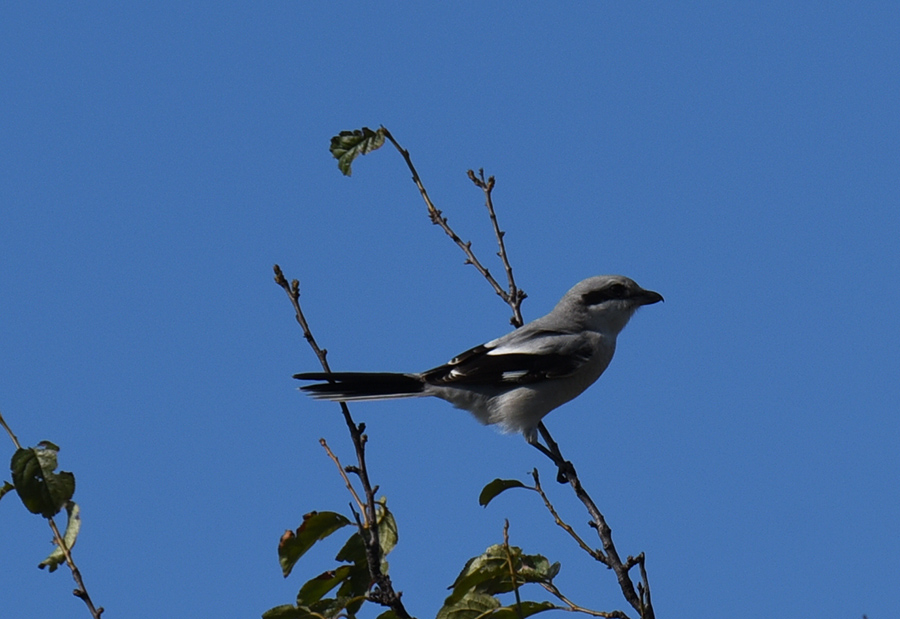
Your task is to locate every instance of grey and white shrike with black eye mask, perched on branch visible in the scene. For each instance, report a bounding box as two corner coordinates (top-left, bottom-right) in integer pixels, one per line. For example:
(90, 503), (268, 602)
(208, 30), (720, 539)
(294, 275), (663, 457)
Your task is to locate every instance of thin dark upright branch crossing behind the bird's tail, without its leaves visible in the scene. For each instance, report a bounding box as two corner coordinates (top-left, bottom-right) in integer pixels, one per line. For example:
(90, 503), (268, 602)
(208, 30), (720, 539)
(274, 264), (412, 619)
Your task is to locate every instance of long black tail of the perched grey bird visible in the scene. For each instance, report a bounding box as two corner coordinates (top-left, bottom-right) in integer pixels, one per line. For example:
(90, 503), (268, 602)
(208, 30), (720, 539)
(294, 372), (425, 402)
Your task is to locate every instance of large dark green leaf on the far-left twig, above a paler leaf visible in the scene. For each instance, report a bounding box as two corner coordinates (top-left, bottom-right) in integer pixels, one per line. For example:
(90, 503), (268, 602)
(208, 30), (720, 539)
(10, 441), (75, 518)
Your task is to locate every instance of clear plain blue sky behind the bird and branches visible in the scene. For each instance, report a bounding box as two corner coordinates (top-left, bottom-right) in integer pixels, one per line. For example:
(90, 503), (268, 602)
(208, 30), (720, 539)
(0, 2), (900, 619)
